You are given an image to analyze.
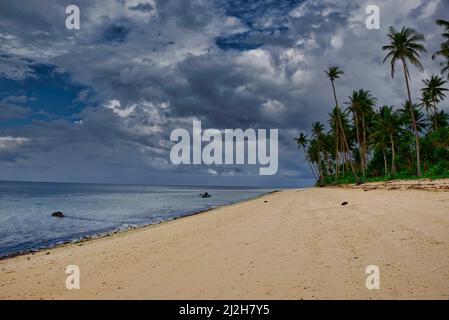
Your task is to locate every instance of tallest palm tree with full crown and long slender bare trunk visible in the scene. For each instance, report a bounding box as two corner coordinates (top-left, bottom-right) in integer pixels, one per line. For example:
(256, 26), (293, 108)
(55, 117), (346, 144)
(382, 27), (426, 177)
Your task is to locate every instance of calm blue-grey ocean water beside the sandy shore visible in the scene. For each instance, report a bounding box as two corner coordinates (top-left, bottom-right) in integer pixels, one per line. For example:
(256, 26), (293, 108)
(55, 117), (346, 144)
(0, 182), (272, 256)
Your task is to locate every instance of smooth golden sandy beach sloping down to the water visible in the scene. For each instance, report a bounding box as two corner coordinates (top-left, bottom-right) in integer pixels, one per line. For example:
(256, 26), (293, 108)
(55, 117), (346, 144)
(0, 181), (449, 299)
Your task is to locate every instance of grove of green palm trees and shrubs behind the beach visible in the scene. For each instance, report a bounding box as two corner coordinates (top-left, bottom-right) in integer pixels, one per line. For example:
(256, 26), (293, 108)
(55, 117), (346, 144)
(295, 20), (449, 185)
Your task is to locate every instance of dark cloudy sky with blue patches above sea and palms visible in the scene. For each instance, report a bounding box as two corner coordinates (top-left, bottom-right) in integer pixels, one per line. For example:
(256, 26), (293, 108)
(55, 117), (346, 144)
(0, 0), (449, 186)
